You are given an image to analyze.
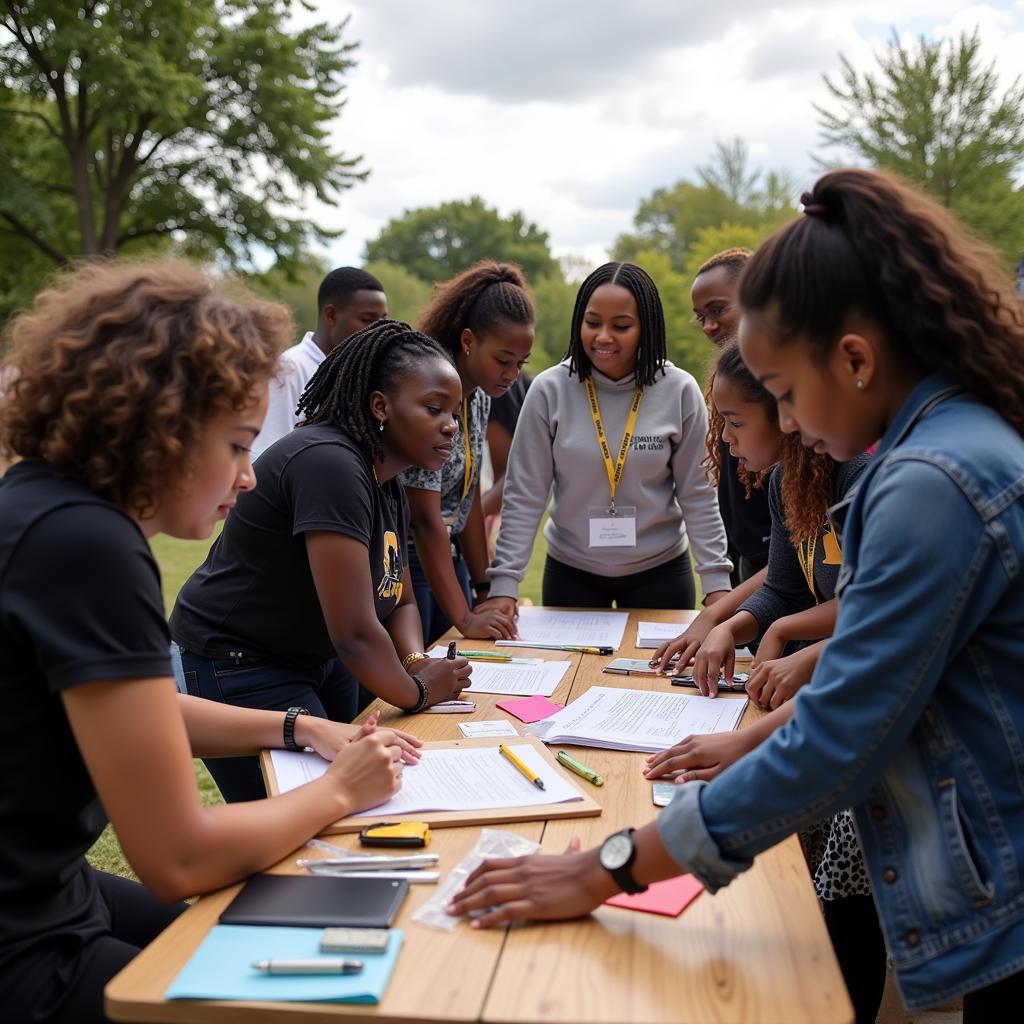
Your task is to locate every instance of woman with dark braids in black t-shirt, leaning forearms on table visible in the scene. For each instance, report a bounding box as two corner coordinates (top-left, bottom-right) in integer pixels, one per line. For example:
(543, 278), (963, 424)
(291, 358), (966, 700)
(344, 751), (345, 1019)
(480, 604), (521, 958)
(171, 319), (472, 801)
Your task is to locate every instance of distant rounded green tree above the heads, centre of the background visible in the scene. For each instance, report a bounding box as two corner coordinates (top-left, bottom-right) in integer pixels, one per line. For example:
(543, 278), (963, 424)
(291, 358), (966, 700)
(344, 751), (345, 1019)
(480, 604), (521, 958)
(366, 196), (558, 284)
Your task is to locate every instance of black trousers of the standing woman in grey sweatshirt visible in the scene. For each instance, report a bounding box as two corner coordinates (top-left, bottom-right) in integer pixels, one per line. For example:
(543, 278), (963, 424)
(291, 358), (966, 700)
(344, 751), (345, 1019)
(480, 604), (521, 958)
(542, 551), (696, 609)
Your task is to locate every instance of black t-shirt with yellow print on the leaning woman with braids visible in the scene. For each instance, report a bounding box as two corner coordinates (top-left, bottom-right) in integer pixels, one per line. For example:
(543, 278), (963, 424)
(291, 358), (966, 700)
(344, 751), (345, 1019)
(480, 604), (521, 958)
(171, 424), (409, 669)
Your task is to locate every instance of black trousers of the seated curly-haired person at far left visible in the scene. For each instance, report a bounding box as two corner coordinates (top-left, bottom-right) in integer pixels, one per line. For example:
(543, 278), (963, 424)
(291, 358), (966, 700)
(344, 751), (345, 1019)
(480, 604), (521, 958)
(6, 867), (188, 1024)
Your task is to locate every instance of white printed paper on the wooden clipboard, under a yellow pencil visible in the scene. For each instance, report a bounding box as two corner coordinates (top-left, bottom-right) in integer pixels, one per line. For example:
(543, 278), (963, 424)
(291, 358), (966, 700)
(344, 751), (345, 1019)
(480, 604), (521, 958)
(270, 743), (583, 817)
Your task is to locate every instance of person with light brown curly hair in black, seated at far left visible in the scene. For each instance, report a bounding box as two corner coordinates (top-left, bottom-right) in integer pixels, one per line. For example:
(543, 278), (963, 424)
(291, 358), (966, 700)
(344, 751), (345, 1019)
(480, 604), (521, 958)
(0, 262), (407, 1024)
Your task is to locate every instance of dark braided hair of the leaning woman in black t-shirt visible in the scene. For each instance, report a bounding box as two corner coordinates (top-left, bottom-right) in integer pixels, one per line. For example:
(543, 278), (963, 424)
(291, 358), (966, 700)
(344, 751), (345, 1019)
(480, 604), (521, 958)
(298, 319), (452, 462)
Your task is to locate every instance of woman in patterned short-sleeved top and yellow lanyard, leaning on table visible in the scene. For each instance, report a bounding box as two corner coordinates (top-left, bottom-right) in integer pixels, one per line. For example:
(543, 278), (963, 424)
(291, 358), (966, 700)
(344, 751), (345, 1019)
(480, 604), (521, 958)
(401, 260), (534, 646)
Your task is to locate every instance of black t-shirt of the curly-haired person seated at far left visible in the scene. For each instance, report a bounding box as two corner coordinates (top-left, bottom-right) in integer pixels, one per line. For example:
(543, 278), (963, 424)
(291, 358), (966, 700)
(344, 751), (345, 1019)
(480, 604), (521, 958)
(0, 460), (171, 958)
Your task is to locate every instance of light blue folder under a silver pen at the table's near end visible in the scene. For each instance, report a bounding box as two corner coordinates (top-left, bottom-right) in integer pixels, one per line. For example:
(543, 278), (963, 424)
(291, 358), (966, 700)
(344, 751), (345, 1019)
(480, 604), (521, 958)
(164, 925), (402, 1002)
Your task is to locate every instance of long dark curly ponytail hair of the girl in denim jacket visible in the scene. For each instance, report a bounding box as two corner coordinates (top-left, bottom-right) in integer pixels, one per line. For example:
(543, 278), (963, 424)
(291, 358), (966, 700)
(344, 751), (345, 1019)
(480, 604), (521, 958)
(739, 170), (1024, 433)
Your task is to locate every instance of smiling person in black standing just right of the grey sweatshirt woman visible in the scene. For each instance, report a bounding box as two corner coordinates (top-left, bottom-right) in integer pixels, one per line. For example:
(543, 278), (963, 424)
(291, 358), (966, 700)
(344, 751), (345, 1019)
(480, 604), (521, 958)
(690, 248), (771, 587)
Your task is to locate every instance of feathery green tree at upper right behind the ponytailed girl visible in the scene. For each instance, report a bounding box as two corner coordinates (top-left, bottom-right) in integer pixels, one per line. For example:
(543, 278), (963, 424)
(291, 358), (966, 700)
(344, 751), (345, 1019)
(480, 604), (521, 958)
(815, 32), (1024, 259)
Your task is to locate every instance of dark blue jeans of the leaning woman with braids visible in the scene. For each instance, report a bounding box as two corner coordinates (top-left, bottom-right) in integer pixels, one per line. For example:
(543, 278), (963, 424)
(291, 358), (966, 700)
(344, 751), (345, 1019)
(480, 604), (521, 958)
(181, 649), (373, 804)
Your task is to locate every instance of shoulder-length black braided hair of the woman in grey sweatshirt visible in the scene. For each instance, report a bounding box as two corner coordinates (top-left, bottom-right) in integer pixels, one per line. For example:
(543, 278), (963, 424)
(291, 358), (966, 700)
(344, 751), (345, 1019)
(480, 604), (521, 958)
(564, 263), (669, 387)
